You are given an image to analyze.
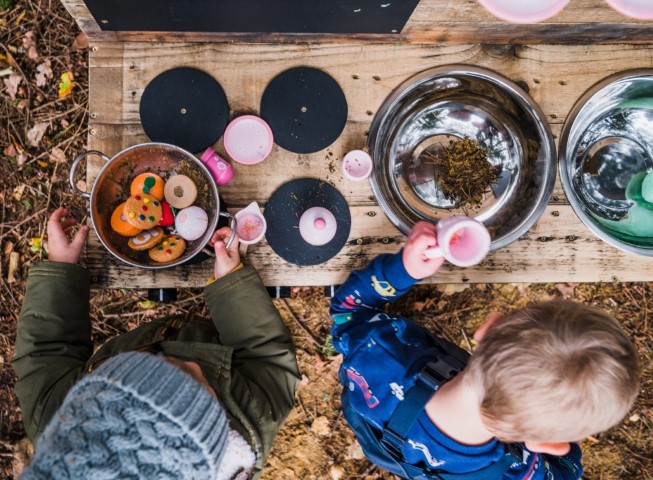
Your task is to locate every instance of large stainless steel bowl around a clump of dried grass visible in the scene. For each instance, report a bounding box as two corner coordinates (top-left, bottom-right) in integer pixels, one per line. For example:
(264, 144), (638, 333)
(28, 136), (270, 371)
(368, 65), (556, 250)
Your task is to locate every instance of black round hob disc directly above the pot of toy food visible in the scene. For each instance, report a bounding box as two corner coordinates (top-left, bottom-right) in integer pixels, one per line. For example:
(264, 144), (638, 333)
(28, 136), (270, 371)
(140, 67), (229, 153)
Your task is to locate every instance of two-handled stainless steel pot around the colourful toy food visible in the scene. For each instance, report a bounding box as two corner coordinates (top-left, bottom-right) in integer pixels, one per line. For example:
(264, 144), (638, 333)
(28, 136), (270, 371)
(69, 143), (236, 270)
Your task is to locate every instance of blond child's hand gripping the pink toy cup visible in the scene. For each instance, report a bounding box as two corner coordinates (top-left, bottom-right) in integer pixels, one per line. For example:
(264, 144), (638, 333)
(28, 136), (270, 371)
(402, 222), (444, 280)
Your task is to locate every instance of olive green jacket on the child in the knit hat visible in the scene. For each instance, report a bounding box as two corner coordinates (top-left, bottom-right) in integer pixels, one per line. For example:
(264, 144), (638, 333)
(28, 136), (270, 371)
(13, 262), (300, 477)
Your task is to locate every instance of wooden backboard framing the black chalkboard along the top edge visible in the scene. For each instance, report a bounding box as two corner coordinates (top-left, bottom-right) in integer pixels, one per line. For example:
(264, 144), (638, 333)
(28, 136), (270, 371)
(63, 0), (653, 44)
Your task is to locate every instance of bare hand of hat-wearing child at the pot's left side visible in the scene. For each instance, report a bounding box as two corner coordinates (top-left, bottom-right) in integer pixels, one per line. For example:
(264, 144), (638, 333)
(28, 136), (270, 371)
(48, 207), (88, 264)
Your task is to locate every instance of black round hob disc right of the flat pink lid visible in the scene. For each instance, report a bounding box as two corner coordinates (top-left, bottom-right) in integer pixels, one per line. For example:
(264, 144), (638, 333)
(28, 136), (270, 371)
(261, 67), (347, 153)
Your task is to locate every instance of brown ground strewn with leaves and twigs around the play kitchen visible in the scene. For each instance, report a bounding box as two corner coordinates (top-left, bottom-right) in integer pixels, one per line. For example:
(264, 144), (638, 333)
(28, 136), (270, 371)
(0, 0), (653, 480)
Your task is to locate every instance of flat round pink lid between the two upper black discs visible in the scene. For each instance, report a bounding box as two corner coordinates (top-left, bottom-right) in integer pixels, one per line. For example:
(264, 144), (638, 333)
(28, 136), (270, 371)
(224, 115), (274, 165)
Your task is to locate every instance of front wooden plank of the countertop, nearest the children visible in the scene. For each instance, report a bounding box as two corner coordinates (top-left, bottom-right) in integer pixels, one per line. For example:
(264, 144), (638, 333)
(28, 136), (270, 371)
(86, 205), (653, 288)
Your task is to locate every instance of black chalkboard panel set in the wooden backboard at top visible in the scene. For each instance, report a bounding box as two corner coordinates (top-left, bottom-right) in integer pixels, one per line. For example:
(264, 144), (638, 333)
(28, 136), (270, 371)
(84, 0), (419, 34)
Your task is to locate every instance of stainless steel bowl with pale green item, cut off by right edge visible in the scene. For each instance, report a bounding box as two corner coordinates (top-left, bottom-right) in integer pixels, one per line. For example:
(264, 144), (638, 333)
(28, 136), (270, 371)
(559, 69), (653, 256)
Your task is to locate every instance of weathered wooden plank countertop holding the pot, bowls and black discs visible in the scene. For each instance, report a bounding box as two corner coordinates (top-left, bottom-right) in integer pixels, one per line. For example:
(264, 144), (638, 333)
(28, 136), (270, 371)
(80, 41), (653, 288)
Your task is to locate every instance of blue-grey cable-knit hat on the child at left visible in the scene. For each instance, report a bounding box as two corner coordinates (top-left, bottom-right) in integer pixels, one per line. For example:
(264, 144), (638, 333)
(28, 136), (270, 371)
(21, 352), (229, 480)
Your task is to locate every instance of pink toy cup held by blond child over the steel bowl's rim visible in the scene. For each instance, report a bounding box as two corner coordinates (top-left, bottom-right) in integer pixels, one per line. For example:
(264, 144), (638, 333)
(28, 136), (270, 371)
(424, 216), (492, 267)
